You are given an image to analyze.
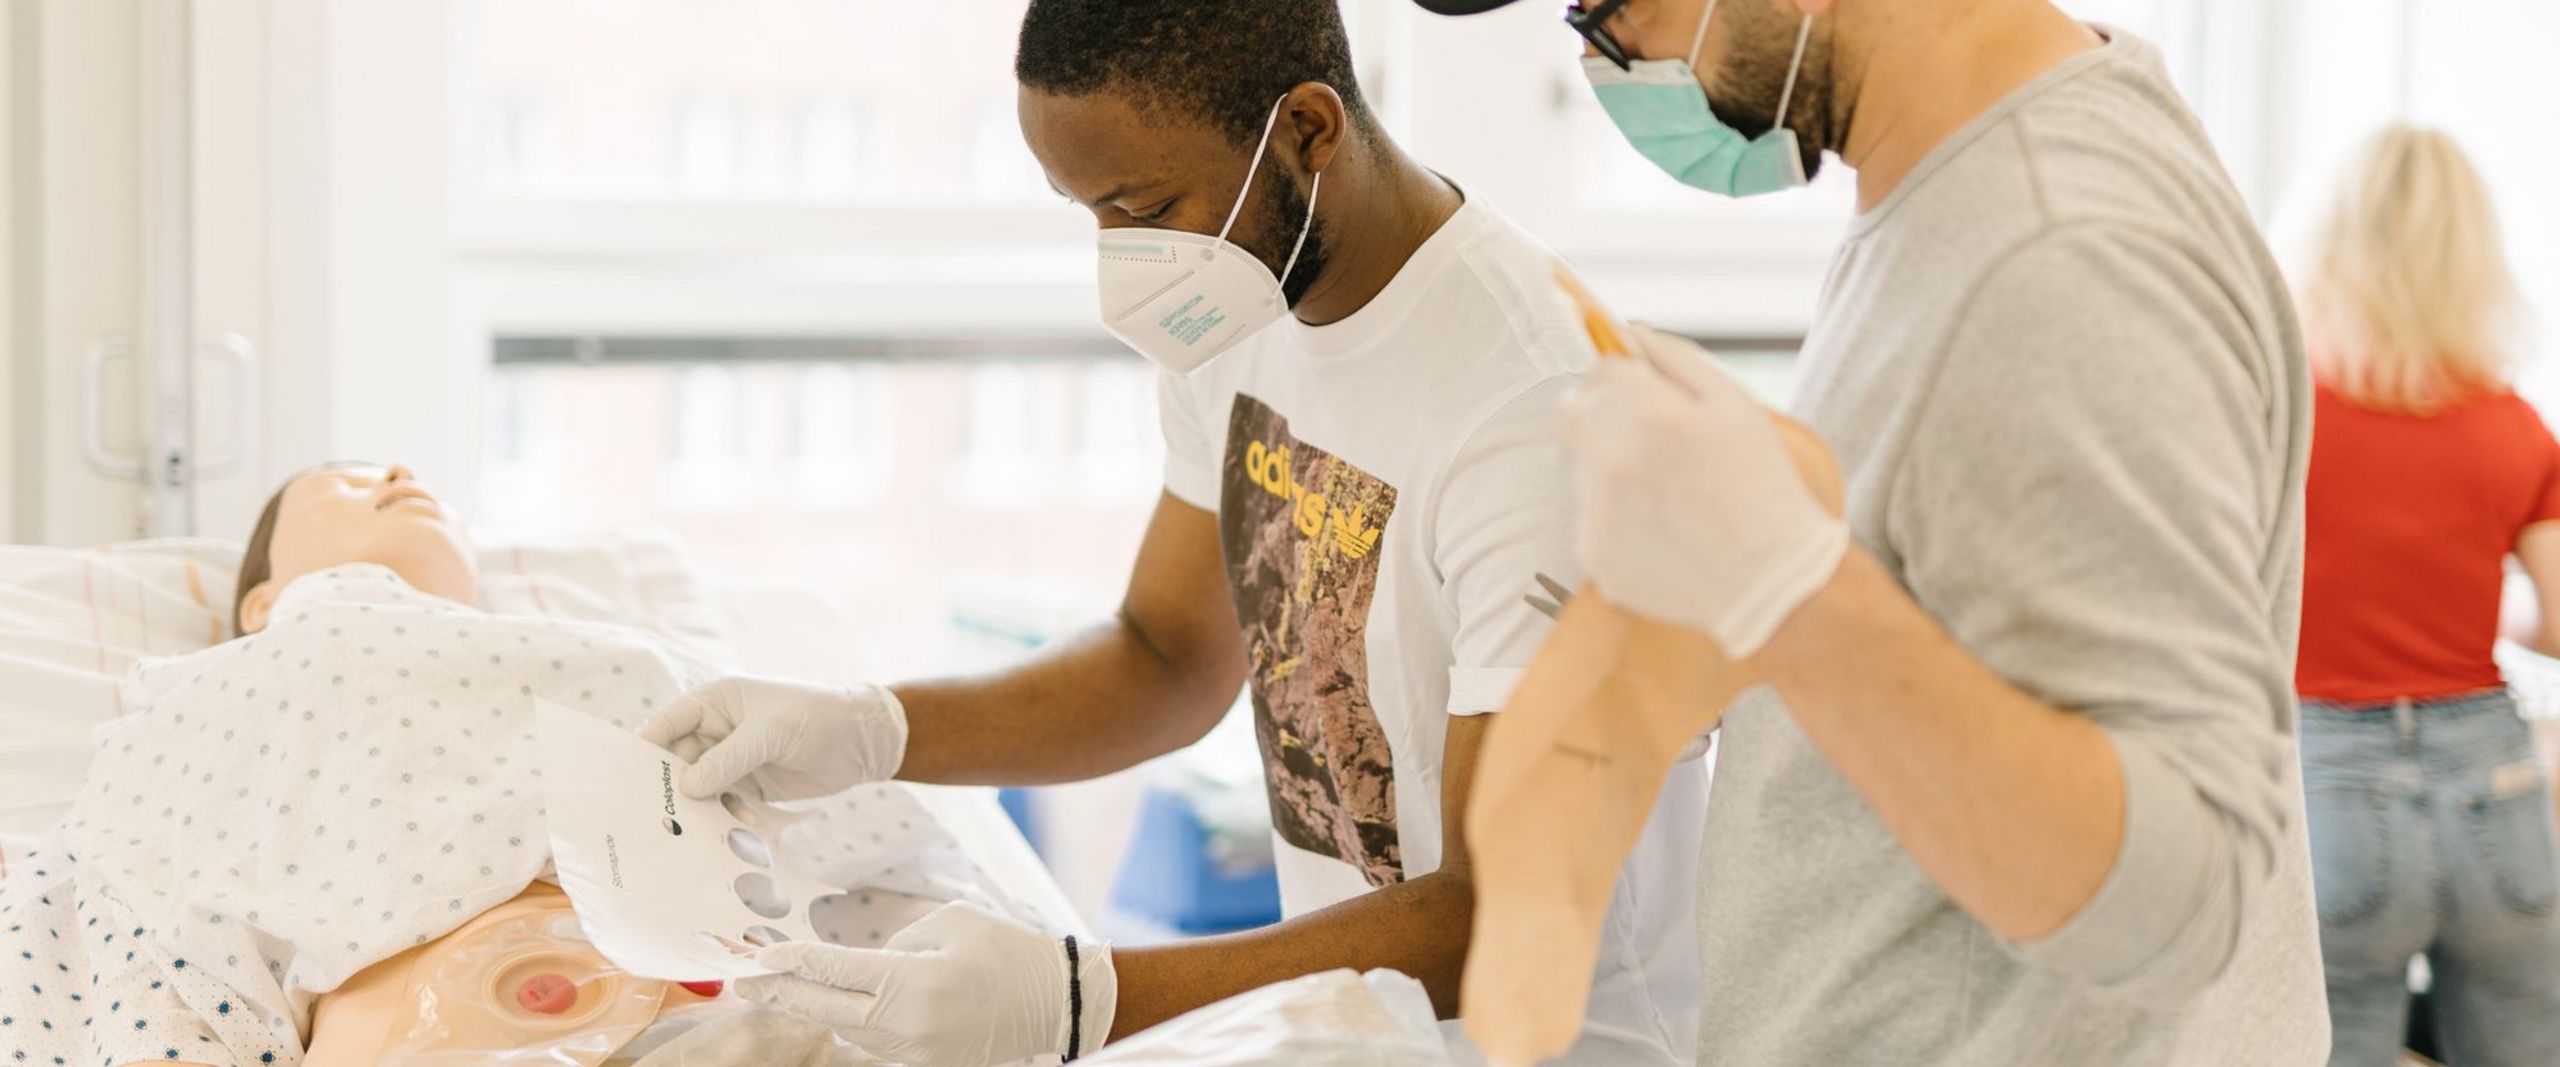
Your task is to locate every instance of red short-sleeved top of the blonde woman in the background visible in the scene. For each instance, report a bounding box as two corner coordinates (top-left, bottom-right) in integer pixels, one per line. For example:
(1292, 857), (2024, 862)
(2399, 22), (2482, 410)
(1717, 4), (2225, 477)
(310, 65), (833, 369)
(2294, 386), (2560, 704)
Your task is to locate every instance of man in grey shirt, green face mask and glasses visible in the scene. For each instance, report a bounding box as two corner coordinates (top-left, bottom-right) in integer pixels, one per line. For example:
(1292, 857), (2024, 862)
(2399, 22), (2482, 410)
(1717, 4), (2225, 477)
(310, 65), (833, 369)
(1421, 0), (2330, 1064)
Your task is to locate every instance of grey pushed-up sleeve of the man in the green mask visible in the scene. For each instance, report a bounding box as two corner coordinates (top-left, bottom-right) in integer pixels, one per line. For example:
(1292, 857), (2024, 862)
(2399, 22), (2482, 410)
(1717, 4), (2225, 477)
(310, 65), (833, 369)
(1887, 225), (2301, 1006)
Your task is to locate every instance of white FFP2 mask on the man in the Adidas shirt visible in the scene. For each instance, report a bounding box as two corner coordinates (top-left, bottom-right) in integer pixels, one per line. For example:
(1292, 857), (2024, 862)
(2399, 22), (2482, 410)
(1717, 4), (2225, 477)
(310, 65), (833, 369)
(1098, 97), (1324, 374)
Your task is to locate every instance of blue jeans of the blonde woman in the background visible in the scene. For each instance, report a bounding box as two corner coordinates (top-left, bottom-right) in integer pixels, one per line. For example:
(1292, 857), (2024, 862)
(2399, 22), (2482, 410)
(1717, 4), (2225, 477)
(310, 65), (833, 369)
(2301, 691), (2560, 1067)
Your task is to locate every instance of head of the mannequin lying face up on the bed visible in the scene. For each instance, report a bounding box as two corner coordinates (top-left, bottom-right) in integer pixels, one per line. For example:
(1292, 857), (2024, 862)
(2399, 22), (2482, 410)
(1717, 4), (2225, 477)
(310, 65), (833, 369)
(233, 463), (479, 635)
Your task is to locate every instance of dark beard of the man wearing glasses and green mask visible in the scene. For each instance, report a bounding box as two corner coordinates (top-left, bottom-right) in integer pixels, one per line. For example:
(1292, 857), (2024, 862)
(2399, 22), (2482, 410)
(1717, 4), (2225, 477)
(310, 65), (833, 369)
(1708, 3), (1838, 179)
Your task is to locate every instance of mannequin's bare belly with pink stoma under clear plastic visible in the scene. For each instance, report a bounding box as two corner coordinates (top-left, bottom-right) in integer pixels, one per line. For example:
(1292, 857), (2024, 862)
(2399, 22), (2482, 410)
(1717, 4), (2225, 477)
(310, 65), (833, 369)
(307, 883), (717, 1067)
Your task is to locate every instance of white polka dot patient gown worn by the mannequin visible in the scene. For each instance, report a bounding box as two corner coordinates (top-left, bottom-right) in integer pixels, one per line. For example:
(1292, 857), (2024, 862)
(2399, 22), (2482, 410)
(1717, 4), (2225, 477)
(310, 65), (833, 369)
(0, 565), (1059, 1067)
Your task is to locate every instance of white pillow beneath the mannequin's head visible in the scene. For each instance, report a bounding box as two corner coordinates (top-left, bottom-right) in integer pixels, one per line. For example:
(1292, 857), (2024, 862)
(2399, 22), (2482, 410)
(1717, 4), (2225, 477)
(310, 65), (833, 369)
(0, 535), (732, 834)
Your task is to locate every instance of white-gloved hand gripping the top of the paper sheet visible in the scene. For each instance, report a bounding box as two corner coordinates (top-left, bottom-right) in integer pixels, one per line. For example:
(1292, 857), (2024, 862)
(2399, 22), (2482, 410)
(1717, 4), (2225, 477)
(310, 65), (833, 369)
(640, 678), (906, 801)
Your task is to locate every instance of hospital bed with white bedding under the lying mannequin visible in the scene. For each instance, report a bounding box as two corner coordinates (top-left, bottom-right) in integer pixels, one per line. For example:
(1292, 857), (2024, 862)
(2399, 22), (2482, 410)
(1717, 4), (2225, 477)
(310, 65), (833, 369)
(0, 535), (1088, 931)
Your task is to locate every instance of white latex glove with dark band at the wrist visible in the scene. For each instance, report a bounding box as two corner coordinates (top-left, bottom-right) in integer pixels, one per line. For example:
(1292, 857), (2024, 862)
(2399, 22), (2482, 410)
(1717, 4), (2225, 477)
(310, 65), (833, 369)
(730, 903), (1119, 1067)
